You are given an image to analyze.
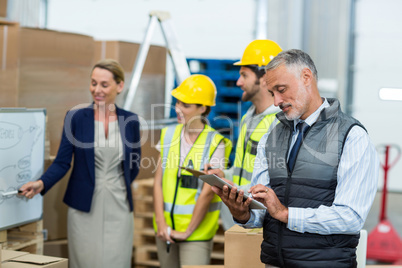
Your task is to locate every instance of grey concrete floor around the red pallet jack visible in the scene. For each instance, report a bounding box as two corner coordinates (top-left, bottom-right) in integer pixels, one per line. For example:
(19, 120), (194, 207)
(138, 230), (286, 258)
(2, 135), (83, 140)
(363, 192), (402, 264)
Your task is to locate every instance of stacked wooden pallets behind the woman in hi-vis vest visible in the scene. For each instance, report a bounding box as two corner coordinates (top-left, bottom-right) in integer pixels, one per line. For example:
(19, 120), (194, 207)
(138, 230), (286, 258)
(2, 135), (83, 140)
(133, 178), (225, 268)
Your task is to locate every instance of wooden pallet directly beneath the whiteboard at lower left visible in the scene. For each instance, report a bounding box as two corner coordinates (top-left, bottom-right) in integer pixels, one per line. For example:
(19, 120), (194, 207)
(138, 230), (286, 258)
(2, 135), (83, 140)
(0, 220), (43, 255)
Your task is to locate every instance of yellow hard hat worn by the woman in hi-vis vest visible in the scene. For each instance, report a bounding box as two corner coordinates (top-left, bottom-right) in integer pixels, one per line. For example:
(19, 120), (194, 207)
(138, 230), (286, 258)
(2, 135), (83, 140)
(172, 74), (216, 106)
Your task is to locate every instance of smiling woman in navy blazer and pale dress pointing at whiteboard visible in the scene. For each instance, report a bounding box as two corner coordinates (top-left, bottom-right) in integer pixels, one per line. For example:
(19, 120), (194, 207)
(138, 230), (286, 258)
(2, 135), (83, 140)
(20, 60), (141, 268)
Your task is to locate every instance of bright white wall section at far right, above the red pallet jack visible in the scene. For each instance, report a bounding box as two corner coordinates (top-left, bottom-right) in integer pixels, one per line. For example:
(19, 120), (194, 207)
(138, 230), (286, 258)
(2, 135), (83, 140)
(352, 0), (402, 192)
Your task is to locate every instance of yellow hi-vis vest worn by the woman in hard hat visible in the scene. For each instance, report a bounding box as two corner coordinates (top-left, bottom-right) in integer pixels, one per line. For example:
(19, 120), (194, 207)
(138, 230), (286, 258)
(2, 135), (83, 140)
(154, 124), (231, 241)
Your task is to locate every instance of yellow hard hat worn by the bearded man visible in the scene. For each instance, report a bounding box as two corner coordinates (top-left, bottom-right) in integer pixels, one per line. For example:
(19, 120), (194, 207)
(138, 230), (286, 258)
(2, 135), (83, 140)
(233, 40), (282, 67)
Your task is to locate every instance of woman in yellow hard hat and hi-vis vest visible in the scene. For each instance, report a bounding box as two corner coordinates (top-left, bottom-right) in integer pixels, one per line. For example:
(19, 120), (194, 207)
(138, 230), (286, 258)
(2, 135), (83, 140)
(153, 74), (232, 268)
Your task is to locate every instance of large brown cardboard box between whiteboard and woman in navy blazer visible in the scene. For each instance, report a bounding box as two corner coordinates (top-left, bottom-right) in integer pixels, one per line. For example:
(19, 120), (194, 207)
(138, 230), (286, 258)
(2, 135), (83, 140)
(18, 28), (94, 155)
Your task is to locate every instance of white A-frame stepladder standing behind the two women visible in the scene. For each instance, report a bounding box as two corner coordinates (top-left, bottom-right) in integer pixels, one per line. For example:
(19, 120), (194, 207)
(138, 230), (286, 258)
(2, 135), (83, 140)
(124, 11), (190, 110)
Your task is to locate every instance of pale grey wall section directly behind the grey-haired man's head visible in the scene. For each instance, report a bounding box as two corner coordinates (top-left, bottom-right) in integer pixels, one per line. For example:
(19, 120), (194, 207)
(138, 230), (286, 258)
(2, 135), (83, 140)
(268, 0), (352, 110)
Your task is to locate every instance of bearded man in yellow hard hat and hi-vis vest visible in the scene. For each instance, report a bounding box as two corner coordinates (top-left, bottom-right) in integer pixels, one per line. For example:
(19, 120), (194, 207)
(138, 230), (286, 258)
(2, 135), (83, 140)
(208, 40), (282, 229)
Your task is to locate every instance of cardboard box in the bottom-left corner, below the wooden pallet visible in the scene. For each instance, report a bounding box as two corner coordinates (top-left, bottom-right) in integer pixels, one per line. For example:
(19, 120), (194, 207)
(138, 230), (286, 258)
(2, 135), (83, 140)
(1, 250), (68, 268)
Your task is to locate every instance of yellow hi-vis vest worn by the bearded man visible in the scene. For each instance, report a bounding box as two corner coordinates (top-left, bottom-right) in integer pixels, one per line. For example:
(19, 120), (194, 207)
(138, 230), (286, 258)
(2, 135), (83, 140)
(233, 114), (279, 185)
